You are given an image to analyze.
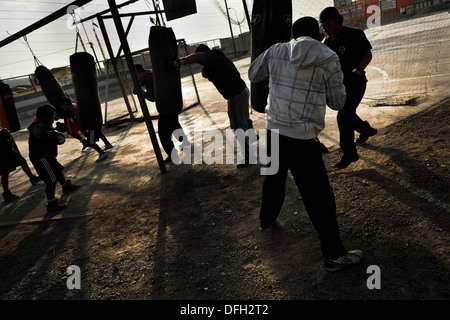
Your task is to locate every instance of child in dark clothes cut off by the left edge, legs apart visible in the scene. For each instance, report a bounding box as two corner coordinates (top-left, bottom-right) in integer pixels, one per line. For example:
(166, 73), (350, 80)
(0, 128), (40, 202)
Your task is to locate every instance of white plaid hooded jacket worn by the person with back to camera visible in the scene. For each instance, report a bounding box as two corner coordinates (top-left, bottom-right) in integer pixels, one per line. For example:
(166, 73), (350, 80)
(248, 36), (346, 140)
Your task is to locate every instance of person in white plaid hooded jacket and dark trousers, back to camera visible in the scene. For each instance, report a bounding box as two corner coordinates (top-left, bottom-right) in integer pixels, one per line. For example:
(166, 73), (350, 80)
(248, 17), (362, 271)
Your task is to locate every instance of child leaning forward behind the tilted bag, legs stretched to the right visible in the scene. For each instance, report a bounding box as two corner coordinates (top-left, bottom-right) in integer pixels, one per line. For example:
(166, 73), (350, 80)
(60, 97), (113, 161)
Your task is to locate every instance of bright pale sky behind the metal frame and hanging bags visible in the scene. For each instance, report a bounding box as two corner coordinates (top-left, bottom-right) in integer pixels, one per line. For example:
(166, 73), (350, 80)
(0, 0), (333, 79)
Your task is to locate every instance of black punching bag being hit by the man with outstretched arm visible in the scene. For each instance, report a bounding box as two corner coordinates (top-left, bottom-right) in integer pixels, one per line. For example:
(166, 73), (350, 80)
(148, 26), (183, 115)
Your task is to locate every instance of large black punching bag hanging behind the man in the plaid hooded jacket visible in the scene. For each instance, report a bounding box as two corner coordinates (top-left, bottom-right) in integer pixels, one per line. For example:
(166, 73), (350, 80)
(250, 0), (292, 113)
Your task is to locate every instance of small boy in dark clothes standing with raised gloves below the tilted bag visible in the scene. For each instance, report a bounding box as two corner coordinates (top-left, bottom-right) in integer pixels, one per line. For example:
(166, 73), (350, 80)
(27, 104), (79, 212)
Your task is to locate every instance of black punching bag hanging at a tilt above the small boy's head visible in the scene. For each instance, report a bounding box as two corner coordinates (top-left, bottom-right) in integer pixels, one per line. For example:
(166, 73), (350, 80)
(34, 66), (70, 119)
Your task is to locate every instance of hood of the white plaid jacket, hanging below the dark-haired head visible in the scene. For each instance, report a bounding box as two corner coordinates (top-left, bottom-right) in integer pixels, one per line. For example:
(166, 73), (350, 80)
(286, 36), (339, 69)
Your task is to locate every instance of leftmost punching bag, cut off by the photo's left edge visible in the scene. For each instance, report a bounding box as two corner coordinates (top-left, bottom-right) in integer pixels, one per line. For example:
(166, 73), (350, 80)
(0, 81), (20, 132)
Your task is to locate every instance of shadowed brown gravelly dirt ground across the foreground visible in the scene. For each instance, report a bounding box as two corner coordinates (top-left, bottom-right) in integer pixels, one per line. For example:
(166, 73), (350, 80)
(0, 87), (450, 300)
